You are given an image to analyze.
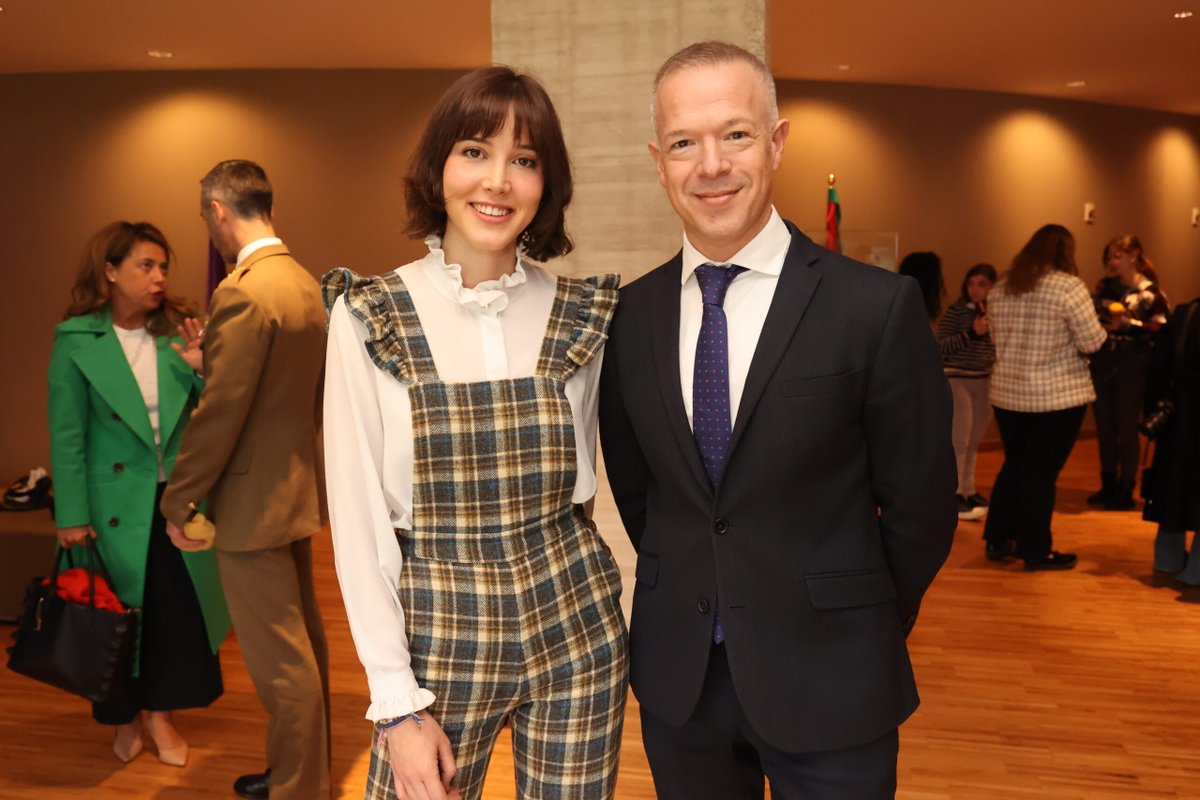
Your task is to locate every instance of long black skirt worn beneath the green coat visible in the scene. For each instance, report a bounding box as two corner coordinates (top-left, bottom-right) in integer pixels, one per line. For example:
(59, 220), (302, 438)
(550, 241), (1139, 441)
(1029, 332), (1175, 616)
(91, 485), (223, 724)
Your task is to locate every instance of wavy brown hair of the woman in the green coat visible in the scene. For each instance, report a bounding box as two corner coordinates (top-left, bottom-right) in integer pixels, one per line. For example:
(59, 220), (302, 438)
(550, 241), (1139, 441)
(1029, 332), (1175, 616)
(62, 221), (197, 336)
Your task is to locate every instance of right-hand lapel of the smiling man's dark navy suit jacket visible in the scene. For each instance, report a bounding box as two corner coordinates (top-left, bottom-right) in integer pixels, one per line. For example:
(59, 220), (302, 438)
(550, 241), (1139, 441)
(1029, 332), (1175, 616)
(726, 223), (821, 458)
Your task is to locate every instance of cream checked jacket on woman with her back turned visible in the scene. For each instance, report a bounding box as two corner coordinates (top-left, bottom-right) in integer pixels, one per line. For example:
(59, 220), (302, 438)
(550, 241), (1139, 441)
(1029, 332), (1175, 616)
(988, 271), (1108, 413)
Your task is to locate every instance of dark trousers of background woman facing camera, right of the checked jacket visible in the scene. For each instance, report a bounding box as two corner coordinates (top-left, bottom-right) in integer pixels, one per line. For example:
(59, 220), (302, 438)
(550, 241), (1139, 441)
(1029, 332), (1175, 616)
(1092, 344), (1150, 486)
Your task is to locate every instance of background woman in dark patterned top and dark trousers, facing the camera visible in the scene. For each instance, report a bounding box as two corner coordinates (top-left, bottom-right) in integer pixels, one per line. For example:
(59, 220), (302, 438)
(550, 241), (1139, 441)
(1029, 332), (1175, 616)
(1087, 235), (1170, 511)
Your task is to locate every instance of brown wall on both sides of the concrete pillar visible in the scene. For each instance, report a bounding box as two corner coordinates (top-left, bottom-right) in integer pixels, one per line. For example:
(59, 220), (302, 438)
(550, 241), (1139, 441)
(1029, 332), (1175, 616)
(0, 71), (1200, 481)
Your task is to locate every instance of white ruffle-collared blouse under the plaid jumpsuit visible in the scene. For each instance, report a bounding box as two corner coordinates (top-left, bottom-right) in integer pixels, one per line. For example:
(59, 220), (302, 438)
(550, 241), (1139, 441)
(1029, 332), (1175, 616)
(324, 236), (602, 720)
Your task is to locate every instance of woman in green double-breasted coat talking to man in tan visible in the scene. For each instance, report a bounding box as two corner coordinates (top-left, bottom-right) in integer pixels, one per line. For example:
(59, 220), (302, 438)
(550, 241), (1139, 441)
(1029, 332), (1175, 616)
(49, 222), (229, 766)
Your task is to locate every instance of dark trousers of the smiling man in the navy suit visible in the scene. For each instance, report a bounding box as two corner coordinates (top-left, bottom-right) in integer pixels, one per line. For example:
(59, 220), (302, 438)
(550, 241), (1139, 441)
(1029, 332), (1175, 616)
(642, 645), (900, 800)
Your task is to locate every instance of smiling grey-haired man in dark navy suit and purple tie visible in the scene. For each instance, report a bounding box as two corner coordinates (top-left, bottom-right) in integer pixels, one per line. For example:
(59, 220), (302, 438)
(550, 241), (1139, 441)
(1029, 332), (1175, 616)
(600, 42), (956, 800)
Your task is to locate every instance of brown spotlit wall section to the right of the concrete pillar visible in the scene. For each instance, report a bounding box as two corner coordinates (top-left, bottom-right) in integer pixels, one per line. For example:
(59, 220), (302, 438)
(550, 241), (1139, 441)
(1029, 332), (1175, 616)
(776, 80), (1200, 301)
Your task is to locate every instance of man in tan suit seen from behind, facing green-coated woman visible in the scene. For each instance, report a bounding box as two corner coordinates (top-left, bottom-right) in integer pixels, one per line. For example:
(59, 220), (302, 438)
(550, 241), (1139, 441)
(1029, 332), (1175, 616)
(162, 161), (330, 800)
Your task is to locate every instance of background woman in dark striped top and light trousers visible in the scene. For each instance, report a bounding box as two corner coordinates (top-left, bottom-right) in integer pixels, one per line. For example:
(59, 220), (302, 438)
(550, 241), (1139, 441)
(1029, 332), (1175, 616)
(937, 264), (996, 519)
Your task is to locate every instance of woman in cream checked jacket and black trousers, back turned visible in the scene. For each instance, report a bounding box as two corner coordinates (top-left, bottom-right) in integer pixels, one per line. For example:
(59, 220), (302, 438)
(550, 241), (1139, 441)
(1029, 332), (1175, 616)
(984, 224), (1105, 570)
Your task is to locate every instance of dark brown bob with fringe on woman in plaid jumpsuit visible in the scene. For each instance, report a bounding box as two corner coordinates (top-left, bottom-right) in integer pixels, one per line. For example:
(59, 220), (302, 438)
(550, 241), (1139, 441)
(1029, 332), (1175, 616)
(404, 66), (575, 261)
